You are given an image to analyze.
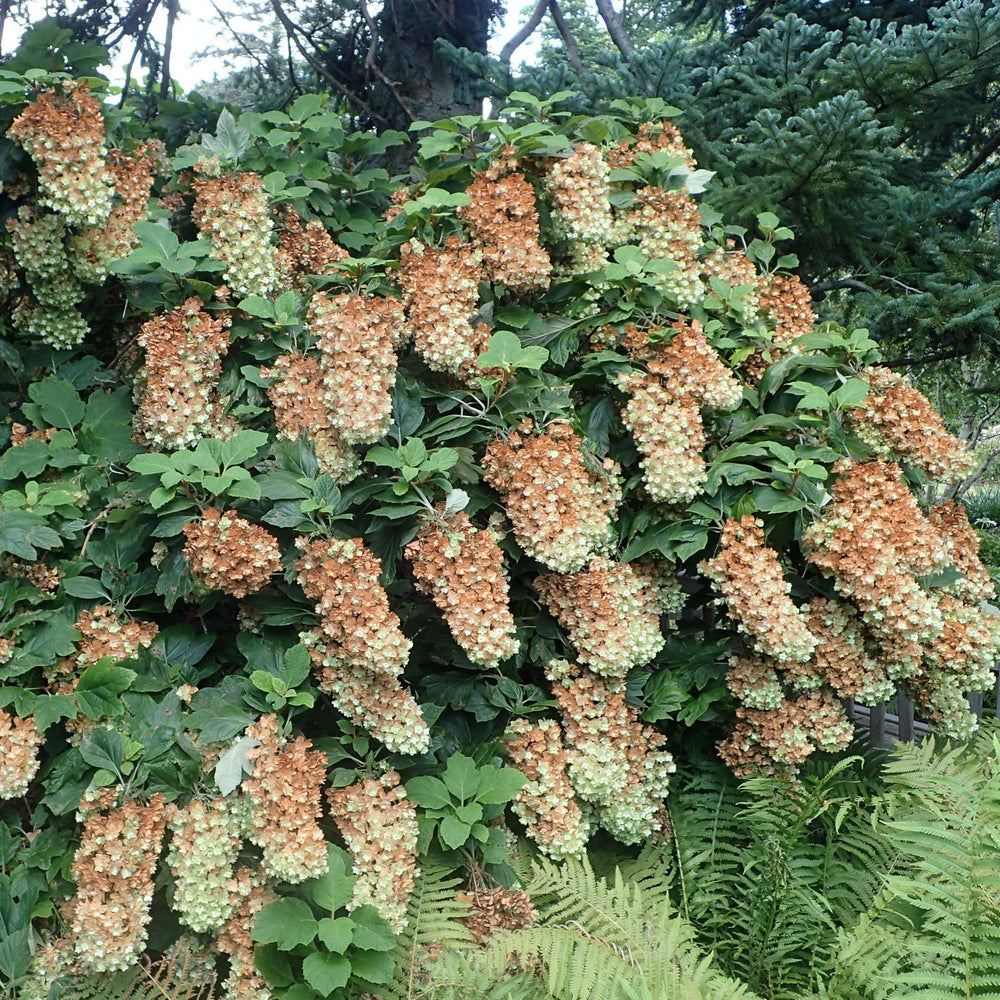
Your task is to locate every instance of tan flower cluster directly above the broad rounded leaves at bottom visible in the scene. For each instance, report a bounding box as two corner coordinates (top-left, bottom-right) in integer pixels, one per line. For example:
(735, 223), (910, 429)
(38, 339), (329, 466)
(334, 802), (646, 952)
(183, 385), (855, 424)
(326, 771), (419, 931)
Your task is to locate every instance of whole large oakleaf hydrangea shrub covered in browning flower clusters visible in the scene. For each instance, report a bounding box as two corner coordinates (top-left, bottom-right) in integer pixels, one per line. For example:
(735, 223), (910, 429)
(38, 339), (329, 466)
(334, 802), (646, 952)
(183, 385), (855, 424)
(0, 45), (998, 1000)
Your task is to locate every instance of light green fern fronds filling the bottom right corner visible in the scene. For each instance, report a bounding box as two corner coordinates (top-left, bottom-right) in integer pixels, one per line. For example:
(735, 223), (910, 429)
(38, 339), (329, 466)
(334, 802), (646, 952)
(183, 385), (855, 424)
(837, 724), (1000, 1000)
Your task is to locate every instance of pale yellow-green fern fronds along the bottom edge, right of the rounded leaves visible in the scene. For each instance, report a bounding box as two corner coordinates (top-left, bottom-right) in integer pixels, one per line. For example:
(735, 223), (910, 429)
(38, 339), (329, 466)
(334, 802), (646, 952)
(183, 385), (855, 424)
(458, 858), (753, 1000)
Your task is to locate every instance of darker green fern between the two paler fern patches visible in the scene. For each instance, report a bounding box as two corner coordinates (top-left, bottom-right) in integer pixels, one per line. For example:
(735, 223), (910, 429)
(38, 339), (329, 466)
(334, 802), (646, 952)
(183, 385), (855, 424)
(669, 758), (894, 1000)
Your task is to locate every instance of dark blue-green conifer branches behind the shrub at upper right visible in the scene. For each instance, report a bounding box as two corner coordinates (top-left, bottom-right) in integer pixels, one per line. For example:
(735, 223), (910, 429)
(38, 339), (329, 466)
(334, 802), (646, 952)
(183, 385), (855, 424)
(467, 0), (1000, 372)
